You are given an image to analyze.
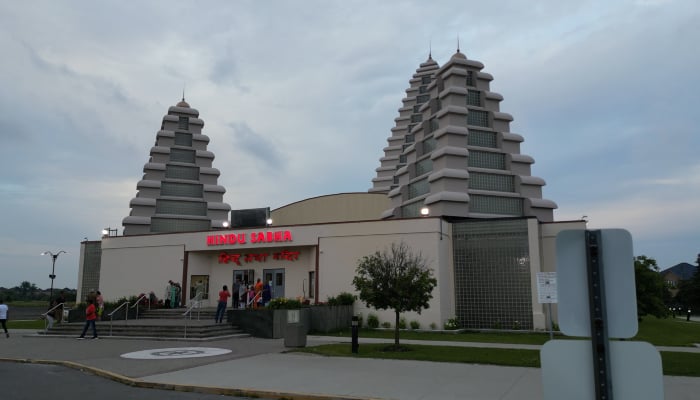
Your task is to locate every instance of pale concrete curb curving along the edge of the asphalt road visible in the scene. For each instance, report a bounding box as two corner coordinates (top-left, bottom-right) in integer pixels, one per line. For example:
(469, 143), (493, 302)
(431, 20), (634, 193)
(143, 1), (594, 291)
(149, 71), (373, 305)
(0, 358), (381, 400)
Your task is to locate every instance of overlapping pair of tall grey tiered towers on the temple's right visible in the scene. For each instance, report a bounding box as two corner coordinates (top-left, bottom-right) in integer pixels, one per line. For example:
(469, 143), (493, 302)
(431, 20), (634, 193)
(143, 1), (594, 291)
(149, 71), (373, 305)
(369, 49), (557, 222)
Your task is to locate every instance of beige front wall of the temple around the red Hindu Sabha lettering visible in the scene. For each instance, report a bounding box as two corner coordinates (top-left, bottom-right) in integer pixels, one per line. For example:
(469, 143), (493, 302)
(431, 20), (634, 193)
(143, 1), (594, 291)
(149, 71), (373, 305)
(93, 217), (585, 329)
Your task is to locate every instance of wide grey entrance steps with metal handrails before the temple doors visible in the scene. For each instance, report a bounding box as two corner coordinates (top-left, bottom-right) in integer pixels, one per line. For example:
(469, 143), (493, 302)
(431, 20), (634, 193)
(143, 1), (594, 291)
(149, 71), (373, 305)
(39, 308), (250, 341)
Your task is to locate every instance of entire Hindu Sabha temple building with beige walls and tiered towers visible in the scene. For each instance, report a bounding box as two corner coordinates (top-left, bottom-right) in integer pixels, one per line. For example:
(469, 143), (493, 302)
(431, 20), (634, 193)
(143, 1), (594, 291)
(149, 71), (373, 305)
(78, 50), (585, 330)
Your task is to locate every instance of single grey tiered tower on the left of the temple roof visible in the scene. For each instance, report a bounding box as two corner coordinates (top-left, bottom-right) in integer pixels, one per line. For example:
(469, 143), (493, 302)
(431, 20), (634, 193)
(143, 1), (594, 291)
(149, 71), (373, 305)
(122, 96), (231, 236)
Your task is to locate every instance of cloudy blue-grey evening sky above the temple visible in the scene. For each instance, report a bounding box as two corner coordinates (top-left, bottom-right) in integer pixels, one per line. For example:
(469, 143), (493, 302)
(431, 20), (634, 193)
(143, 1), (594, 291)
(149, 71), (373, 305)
(0, 0), (700, 288)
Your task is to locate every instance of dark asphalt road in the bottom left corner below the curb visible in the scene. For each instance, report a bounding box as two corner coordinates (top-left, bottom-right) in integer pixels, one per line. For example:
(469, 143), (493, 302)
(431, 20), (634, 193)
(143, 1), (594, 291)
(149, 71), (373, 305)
(0, 362), (270, 400)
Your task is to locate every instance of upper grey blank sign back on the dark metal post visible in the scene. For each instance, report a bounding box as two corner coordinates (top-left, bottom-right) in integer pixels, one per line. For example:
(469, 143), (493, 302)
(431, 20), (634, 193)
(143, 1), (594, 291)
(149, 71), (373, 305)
(556, 229), (638, 338)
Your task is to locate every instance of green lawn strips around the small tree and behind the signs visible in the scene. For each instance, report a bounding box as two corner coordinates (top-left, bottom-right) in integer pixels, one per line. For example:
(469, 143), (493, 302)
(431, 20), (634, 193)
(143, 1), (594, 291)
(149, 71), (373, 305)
(297, 317), (700, 376)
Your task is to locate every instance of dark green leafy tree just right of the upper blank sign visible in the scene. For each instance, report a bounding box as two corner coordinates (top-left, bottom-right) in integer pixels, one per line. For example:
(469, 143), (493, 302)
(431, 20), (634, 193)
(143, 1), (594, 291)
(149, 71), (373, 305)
(634, 256), (669, 318)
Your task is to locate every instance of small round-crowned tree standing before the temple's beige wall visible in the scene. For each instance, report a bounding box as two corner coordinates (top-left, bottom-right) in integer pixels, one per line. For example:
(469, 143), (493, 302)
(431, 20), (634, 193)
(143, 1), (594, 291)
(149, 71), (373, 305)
(352, 242), (437, 350)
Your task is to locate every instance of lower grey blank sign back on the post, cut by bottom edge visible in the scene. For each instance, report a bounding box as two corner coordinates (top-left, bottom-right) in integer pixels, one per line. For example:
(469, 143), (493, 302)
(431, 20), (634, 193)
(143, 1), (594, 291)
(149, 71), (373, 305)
(540, 340), (664, 400)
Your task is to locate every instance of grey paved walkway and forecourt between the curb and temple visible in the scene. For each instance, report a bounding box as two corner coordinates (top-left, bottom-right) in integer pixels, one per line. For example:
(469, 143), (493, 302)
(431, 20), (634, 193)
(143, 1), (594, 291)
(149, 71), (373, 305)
(0, 330), (700, 400)
